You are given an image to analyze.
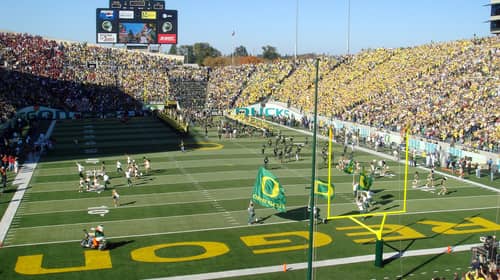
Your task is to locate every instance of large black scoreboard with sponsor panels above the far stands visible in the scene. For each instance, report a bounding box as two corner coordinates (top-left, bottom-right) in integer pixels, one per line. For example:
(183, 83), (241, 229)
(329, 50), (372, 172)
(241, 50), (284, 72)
(96, 0), (177, 44)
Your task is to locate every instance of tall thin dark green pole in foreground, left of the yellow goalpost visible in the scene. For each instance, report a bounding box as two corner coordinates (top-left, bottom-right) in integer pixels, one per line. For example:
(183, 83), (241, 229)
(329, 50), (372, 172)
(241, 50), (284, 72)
(307, 58), (319, 280)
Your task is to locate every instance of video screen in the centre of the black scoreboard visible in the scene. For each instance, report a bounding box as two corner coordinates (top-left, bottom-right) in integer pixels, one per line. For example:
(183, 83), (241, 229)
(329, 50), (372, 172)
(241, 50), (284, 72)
(118, 22), (157, 44)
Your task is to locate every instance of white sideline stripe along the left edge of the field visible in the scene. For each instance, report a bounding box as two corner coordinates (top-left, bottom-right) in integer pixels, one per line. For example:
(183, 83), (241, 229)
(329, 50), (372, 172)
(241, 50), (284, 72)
(0, 121), (56, 243)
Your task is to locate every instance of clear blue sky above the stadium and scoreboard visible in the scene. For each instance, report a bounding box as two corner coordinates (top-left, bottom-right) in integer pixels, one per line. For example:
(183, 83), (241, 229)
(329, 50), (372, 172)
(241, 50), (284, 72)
(0, 0), (490, 55)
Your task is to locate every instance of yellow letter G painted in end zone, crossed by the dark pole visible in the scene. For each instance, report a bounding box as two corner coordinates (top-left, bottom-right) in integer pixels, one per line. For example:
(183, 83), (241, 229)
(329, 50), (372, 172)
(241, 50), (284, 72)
(240, 231), (332, 254)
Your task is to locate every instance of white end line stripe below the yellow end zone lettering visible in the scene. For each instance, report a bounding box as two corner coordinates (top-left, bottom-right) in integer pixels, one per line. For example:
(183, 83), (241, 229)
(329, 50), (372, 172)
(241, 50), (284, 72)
(143, 243), (482, 280)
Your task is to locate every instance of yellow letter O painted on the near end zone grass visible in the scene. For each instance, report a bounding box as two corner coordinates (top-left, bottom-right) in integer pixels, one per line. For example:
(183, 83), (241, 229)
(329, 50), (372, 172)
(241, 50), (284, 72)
(130, 241), (229, 263)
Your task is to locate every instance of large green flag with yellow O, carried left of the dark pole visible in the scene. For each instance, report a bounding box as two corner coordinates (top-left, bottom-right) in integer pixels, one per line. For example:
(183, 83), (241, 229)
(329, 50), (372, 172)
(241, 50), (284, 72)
(252, 167), (286, 212)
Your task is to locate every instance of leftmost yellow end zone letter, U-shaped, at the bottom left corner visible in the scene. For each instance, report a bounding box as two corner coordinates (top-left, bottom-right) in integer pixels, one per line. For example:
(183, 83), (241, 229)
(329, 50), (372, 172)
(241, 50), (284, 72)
(14, 251), (112, 275)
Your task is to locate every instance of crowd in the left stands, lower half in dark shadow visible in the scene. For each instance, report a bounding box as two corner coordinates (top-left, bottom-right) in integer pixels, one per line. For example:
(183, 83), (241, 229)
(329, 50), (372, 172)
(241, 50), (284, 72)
(0, 33), (178, 116)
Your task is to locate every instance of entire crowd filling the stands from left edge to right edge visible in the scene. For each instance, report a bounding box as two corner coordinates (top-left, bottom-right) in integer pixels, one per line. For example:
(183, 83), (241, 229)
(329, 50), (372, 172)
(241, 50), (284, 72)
(0, 33), (500, 152)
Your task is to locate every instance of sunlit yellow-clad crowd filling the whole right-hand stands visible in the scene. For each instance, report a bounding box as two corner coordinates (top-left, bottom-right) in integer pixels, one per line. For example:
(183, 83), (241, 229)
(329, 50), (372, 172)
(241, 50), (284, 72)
(209, 37), (500, 152)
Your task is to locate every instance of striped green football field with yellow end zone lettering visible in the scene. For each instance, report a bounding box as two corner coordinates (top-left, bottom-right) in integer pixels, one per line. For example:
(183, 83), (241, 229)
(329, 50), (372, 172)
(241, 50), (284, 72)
(0, 118), (500, 279)
